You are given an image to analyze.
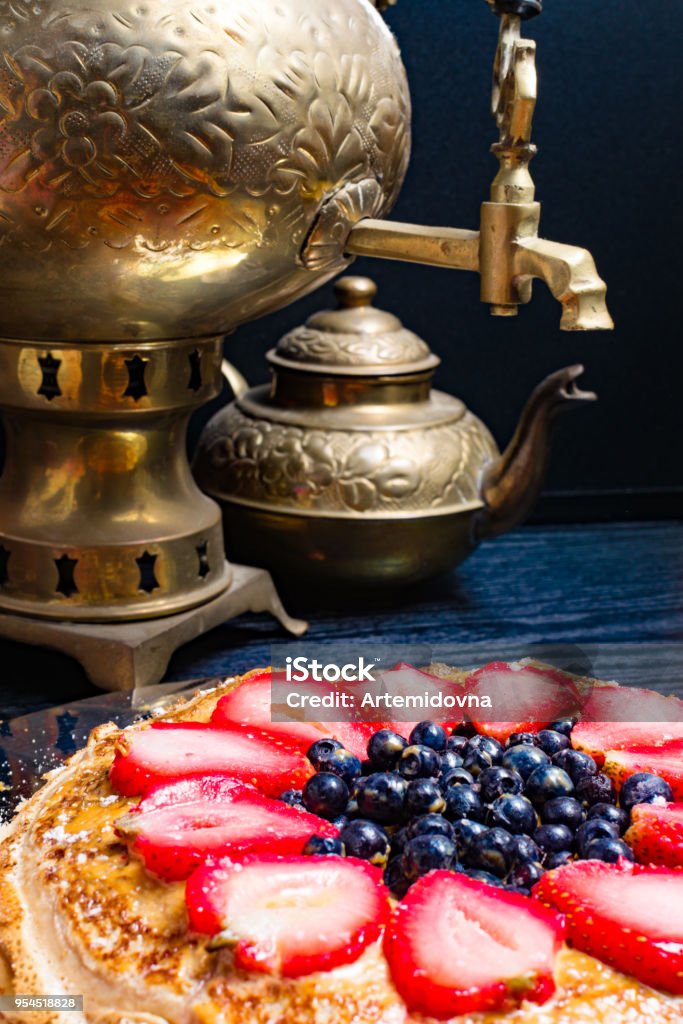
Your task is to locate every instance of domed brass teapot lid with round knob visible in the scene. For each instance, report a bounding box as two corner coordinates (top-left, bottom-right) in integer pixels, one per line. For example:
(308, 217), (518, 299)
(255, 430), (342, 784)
(267, 276), (440, 377)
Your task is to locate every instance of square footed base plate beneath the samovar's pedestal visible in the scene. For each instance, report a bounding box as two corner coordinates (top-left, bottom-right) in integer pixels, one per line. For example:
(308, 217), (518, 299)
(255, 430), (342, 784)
(0, 563), (308, 691)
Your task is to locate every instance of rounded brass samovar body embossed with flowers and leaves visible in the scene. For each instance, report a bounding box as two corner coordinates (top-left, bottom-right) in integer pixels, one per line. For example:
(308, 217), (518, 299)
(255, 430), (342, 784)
(0, 0), (410, 342)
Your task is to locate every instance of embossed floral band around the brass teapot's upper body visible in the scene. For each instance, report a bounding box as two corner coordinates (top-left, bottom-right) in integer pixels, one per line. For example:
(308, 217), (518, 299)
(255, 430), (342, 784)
(196, 403), (498, 514)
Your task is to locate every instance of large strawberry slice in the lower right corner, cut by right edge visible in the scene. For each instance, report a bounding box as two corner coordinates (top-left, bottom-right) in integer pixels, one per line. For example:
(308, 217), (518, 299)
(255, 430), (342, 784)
(533, 858), (683, 995)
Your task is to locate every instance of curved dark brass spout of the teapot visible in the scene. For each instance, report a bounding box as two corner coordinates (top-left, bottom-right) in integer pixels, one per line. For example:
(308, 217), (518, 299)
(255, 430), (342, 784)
(474, 366), (597, 542)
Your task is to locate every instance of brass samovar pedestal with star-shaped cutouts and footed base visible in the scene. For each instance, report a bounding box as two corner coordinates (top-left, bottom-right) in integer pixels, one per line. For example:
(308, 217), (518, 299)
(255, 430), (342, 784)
(0, 338), (306, 689)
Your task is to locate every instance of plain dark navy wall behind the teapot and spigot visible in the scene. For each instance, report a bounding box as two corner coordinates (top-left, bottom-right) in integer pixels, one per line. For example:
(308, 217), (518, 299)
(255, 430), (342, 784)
(190, 0), (683, 521)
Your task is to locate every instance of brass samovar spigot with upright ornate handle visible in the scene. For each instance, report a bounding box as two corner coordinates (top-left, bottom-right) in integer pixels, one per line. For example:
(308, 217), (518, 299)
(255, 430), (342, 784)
(342, 0), (614, 331)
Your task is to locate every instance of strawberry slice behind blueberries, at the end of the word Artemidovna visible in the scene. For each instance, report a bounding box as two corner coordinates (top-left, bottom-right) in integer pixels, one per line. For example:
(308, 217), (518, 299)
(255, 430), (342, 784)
(465, 662), (581, 742)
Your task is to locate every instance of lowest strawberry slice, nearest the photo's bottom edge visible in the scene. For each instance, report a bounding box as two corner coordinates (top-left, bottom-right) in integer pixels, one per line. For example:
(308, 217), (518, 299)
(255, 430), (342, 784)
(384, 871), (564, 1020)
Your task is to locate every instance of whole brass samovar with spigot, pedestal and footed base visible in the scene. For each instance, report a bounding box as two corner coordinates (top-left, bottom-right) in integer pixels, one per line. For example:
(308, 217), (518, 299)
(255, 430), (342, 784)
(0, 0), (610, 686)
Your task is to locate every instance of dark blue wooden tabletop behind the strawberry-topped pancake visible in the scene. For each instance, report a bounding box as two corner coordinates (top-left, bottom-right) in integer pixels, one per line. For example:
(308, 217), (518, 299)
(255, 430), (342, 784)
(0, 522), (683, 719)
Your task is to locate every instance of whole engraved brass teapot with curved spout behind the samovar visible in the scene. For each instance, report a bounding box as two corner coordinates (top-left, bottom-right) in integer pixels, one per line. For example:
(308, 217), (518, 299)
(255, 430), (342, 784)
(195, 276), (595, 587)
